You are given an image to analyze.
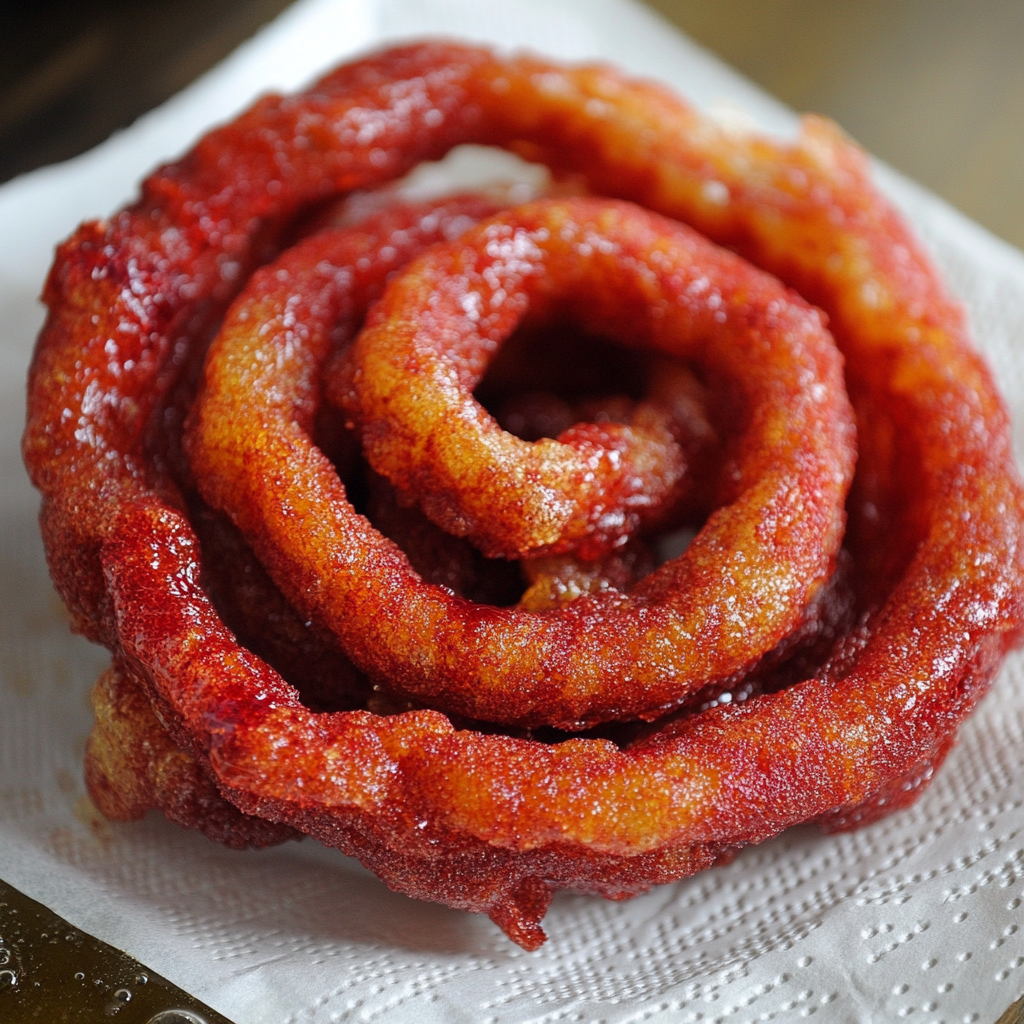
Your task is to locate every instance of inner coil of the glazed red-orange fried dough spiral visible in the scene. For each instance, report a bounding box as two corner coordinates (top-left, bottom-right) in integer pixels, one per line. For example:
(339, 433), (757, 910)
(190, 199), (853, 729)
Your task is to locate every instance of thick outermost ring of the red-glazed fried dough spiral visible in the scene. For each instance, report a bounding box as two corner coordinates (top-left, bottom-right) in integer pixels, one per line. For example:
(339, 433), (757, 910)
(24, 43), (1024, 948)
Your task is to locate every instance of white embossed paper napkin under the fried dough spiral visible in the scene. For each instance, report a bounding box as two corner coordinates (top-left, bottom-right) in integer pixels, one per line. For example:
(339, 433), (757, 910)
(6, 0), (1024, 1024)
